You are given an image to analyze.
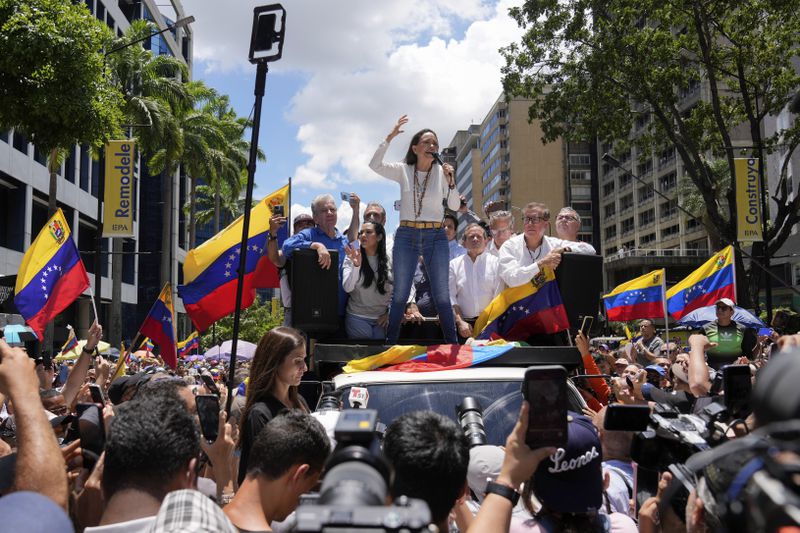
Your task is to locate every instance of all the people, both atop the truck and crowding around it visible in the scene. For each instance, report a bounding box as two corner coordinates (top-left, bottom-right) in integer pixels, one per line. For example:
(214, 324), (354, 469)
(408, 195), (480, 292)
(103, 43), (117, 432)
(0, 116), (800, 533)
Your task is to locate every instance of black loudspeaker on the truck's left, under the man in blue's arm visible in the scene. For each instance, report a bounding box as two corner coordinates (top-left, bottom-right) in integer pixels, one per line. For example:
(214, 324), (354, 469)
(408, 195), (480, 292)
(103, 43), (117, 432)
(290, 249), (339, 333)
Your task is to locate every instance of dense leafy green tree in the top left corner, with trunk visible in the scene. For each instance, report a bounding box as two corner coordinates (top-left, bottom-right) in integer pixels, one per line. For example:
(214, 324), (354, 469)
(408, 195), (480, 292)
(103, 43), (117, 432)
(0, 0), (122, 215)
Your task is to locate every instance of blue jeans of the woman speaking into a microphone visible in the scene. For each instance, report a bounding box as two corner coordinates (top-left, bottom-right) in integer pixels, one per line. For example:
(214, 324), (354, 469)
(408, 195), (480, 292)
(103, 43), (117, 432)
(386, 226), (458, 344)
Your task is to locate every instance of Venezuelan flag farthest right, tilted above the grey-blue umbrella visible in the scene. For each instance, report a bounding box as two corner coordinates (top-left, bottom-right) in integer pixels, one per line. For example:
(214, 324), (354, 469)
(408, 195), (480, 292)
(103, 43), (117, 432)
(667, 245), (736, 320)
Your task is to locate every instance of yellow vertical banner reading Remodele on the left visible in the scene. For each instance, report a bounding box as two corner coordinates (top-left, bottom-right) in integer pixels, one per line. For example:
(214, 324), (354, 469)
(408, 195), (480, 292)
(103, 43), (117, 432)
(103, 140), (136, 237)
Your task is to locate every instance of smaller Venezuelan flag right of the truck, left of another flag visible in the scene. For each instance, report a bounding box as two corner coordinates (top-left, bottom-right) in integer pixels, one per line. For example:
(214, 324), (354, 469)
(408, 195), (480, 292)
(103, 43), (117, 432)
(603, 268), (666, 322)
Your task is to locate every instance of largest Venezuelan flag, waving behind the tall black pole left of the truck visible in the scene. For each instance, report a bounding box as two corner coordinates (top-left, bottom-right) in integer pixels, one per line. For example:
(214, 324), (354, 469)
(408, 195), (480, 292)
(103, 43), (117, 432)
(178, 185), (289, 331)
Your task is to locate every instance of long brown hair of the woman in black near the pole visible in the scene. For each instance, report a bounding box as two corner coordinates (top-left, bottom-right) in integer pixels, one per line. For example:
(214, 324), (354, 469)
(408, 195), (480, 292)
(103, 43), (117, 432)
(237, 326), (307, 447)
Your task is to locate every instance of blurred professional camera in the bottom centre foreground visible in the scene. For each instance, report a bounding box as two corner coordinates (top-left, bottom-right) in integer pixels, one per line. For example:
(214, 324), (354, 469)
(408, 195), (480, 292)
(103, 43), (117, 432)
(294, 410), (431, 533)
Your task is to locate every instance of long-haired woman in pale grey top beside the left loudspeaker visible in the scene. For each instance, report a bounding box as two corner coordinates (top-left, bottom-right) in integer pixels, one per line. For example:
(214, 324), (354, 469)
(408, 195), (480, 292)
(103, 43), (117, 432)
(342, 222), (392, 339)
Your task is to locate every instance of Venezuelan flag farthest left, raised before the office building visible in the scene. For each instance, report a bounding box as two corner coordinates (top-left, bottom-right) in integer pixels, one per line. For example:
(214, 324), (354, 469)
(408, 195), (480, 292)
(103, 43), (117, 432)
(14, 209), (89, 339)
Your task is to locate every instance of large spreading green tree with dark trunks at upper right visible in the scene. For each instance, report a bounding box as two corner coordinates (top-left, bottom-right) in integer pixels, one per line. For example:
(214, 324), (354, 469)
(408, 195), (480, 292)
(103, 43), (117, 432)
(503, 0), (800, 306)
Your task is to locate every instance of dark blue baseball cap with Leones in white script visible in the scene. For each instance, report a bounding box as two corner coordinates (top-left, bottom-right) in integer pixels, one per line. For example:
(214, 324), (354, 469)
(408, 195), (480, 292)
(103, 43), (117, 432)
(533, 411), (603, 513)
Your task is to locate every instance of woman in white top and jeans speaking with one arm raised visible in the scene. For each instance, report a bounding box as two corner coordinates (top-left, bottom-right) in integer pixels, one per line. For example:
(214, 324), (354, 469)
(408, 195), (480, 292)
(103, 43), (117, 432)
(369, 115), (461, 344)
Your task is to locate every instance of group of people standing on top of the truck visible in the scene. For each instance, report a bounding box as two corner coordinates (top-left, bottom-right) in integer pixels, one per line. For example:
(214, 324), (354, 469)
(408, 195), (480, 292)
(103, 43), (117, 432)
(268, 115), (596, 344)
